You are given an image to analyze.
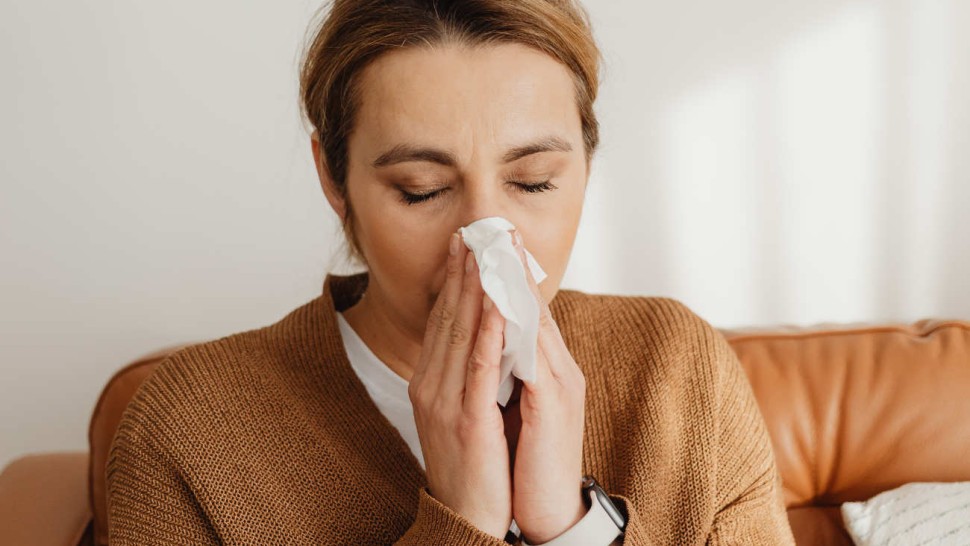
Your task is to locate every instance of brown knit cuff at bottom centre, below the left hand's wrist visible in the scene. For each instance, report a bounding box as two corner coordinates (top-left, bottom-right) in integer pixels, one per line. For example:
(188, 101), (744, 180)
(394, 487), (520, 546)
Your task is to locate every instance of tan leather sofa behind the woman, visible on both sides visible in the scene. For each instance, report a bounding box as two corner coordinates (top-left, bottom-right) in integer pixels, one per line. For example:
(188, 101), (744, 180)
(0, 320), (970, 546)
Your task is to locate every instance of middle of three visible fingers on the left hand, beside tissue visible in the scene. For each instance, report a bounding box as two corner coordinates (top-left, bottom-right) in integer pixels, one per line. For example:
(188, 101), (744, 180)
(439, 252), (484, 398)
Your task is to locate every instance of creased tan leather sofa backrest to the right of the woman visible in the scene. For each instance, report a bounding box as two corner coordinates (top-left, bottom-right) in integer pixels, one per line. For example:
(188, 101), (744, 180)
(723, 320), (970, 544)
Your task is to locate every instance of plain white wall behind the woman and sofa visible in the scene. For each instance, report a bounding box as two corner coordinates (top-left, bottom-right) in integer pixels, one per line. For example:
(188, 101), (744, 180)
(0, 0), (970, 465)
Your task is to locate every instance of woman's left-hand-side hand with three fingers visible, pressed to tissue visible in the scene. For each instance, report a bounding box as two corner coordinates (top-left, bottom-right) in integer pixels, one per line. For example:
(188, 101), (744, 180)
(408, 228), (516, 538)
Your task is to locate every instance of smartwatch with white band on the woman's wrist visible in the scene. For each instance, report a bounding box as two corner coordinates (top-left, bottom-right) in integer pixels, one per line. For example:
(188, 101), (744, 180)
(522, 475), (626, 546)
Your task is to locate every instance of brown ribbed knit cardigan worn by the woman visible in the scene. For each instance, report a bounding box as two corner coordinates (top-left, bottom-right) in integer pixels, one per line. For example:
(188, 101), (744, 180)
(106, 273), (794, 546)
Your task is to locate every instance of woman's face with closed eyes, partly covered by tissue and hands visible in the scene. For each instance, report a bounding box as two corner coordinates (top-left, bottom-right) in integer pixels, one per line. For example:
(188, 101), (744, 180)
(313, 40), (589, 335)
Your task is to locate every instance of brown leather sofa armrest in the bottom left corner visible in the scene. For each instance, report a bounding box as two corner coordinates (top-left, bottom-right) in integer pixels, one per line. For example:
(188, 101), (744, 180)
(0, 452), (91, 546)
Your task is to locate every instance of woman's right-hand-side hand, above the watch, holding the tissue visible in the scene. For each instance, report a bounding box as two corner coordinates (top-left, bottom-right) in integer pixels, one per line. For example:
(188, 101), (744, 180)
(512, 227), (586, 544)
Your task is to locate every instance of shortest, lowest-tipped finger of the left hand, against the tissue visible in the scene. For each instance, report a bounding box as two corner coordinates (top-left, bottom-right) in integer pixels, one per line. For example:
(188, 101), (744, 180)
(464, 294), (505, 416)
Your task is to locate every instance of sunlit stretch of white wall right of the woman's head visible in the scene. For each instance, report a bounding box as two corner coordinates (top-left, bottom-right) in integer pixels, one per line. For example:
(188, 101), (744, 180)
(571, 0), (970, 326)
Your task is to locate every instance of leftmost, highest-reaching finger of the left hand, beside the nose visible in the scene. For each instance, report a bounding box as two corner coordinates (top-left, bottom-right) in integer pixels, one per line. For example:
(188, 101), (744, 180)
(412, 233), (465, 388)
